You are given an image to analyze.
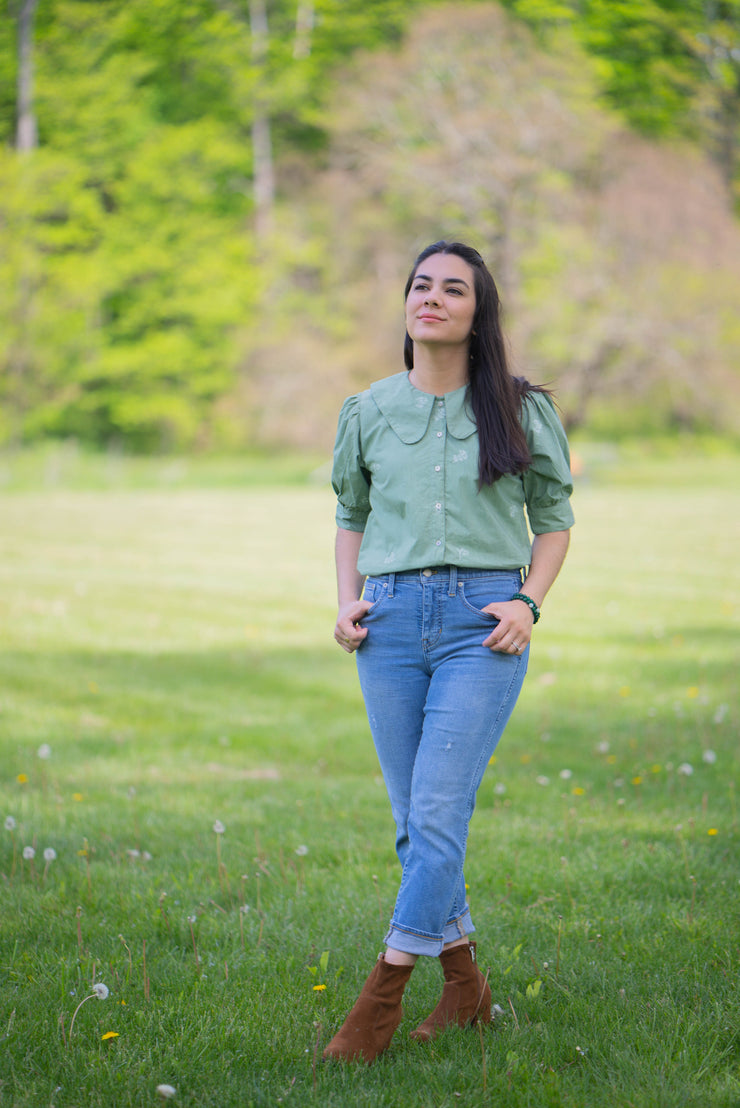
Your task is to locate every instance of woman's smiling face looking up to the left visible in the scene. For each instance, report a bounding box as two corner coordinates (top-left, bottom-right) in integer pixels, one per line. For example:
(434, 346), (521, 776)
(405, 254), (475, 347)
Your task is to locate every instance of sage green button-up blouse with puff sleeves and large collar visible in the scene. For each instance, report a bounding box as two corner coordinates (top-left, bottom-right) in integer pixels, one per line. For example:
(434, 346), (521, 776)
(331, 371), (573, 576)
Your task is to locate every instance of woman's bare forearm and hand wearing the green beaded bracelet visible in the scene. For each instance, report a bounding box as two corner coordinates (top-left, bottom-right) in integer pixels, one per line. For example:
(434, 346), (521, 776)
(483, 530), (571, 654)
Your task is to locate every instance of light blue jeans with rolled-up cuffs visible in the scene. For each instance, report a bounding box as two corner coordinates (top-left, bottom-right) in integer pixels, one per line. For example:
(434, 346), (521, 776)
(357, 566), (528, 956)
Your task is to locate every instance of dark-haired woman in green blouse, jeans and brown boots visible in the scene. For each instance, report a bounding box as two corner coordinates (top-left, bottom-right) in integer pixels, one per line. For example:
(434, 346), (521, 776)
(323, 242), (573, 1061)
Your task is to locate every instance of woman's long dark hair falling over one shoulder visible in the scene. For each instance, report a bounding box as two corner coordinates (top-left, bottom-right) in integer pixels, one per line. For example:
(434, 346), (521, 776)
(403, 239), (547, 486)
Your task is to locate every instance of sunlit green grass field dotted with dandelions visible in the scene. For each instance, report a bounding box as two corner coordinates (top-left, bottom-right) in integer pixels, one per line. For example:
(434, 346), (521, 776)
(0, 450), (740, 1108)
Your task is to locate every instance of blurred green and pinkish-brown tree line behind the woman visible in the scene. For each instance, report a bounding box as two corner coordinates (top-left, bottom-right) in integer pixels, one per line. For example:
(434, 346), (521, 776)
(0, 0), (740, 450)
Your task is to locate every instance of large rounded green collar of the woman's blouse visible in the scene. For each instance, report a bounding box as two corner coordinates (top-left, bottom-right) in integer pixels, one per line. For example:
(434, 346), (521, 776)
(370, 372), (476, 444)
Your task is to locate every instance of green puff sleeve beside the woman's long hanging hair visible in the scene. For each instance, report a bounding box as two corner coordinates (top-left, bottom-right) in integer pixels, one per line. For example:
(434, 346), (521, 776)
(522, 392), (574, 535)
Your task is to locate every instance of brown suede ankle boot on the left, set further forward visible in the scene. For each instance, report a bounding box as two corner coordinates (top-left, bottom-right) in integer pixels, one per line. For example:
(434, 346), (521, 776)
(323, 954), (413, 1061)
